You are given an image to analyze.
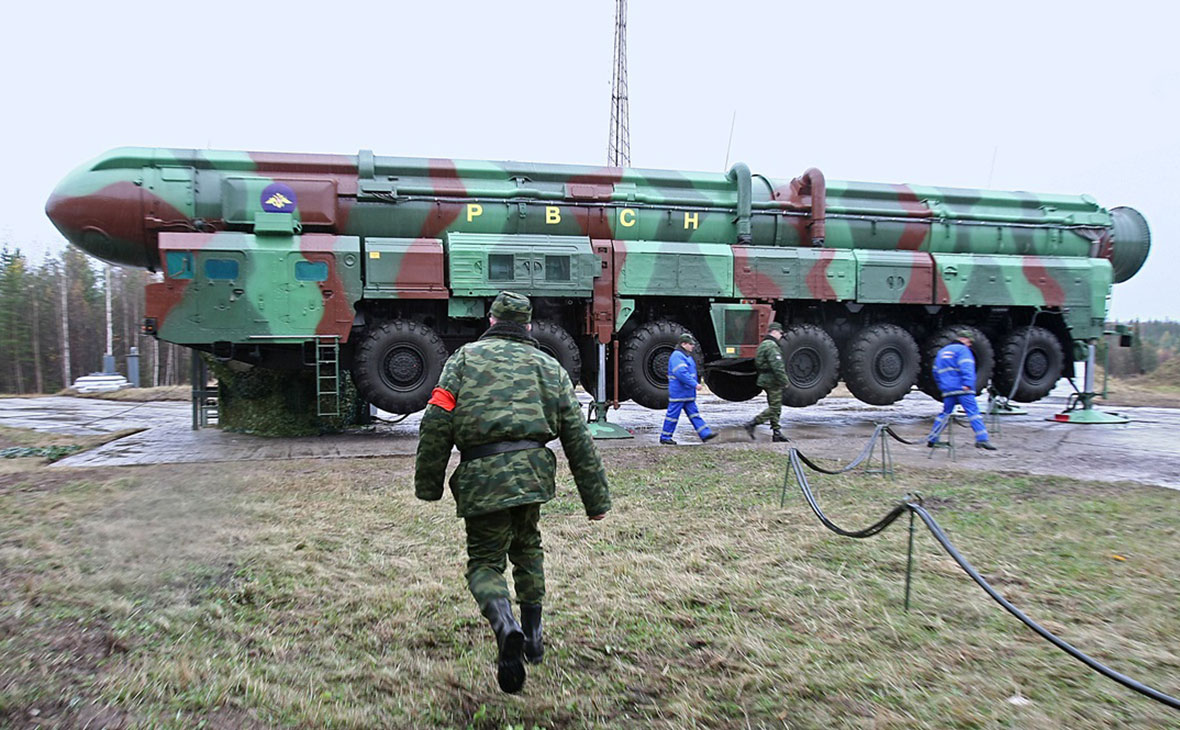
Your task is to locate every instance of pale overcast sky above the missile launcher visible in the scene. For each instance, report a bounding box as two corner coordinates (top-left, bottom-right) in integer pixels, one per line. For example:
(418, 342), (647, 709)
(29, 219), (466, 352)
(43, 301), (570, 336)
(0, 0), (1180, 318)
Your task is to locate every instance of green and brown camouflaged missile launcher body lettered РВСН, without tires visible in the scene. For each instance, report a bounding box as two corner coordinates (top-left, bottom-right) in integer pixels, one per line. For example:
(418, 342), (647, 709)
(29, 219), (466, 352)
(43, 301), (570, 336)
(46, 147), (1151, 412)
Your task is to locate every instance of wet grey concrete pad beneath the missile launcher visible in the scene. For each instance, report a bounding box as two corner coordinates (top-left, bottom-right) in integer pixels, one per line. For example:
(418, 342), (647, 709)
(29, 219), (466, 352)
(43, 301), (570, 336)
(0, 386), (1180, 488)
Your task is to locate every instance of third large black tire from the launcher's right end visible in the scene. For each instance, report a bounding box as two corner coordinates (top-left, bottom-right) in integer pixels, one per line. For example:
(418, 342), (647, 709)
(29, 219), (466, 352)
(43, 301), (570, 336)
(840, 324), (922, 406)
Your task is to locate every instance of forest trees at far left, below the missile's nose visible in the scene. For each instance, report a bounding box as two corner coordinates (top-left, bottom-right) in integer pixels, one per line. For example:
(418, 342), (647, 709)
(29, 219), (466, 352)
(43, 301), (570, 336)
(0, 245), (189, 394)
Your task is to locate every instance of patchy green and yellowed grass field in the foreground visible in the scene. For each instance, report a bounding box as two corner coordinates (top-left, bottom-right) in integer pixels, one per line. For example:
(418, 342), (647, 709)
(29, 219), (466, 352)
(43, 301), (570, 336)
(0, 448), (1180, 729)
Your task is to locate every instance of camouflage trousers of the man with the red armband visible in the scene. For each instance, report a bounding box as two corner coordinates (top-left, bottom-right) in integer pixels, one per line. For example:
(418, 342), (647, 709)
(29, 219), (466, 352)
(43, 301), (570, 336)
(465, 504), (545, 611)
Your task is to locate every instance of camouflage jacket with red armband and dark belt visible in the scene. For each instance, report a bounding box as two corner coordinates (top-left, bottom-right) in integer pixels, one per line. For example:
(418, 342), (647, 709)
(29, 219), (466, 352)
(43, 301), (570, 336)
(414, 322), (610, 518)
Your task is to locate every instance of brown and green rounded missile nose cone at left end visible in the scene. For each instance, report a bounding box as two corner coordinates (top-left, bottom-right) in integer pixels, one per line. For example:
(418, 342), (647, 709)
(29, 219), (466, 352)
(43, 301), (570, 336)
(45, 161), (152, 267)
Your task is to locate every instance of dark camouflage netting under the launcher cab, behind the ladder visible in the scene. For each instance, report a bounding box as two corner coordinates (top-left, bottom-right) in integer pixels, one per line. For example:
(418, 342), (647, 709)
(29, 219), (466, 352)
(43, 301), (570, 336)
(207, 357), (368, 436)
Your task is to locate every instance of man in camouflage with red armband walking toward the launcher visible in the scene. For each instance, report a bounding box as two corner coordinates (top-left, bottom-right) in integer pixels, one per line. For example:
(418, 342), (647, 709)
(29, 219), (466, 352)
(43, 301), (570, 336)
(414, 291), (610, 692)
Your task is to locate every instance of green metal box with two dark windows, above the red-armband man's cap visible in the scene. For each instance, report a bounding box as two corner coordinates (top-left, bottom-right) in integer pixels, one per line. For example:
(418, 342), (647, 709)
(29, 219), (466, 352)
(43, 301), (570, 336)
(446, 232), (602, 297)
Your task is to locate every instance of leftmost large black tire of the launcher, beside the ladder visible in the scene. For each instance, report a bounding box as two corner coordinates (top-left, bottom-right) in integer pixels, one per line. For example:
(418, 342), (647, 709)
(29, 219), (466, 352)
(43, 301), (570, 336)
(353, 320), (447, 413)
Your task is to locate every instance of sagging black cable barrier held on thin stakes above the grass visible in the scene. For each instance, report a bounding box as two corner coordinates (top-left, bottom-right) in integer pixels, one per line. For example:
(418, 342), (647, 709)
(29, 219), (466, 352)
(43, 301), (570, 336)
(784, 436), (1180, 710)
